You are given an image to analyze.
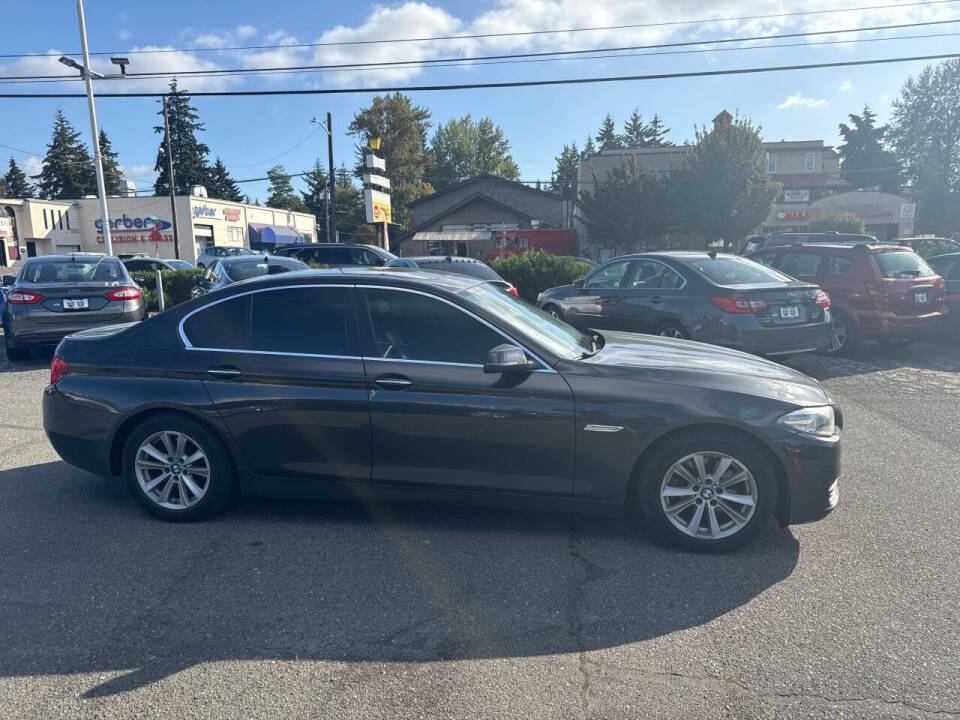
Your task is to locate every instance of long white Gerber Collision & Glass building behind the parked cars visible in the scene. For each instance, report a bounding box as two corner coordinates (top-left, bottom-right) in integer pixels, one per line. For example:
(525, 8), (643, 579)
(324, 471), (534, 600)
(0, 195), (317, 265)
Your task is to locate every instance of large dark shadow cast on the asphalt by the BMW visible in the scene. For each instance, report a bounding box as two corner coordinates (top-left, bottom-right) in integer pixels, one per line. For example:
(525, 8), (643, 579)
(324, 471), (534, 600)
(0, 462), (799, 697)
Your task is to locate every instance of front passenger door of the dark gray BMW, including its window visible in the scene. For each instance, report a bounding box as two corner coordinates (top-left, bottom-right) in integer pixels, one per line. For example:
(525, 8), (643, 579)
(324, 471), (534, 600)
(359, 287), (574, 495)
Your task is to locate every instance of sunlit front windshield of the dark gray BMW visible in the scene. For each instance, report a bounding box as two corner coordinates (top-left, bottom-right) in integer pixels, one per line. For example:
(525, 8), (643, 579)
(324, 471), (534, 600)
(459, 283), (594, 360)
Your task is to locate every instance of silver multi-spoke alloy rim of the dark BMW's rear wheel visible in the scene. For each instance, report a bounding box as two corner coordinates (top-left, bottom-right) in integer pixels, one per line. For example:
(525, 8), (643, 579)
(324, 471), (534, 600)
(134, 430), (210, 510)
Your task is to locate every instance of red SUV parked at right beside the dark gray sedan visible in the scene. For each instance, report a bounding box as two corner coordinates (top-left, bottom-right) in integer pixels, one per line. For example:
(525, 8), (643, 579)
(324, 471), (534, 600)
(749, 243), (947, 353)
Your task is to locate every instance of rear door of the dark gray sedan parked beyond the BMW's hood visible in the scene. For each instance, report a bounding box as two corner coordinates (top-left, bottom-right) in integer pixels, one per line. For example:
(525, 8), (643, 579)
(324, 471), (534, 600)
(604, 258), (686, 333)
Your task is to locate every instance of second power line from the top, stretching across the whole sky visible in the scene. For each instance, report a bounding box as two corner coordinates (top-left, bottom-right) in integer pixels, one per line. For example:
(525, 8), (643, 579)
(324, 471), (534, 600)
(0, 18), (960, 80)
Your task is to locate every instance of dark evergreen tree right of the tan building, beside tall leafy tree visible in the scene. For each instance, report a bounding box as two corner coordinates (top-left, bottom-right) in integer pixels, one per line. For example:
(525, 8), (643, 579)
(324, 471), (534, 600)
(837, 105), (900, 193)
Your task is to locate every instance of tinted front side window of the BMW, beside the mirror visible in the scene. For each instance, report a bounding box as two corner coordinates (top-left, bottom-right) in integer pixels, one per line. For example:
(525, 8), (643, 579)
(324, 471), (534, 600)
(366, 290), (506, 365)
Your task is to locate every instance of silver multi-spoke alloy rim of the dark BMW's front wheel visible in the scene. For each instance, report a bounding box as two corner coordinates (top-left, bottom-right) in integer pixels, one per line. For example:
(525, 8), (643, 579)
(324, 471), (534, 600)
(660, 452), (757, 540)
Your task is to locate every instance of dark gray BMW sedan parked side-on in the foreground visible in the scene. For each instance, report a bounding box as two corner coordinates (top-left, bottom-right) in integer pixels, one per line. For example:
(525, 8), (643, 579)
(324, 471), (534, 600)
(43, 268), (842, 552)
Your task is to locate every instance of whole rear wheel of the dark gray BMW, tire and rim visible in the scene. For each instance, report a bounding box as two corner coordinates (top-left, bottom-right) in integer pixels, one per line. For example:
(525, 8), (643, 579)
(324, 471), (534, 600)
(123, 414), (235, 521)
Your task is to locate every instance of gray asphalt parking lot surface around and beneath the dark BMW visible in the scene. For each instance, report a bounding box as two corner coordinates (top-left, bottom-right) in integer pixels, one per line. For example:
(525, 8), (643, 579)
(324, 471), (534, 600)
(0, 343), (960, 719)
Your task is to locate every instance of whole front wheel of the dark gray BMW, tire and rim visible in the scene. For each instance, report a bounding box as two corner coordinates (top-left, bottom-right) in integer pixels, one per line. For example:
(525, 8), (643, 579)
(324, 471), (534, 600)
(638, 431), (777, 553)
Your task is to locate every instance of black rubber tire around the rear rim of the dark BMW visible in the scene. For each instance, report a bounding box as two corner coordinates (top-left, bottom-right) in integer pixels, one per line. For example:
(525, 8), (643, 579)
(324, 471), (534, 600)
(123, 413), (236, 522)
